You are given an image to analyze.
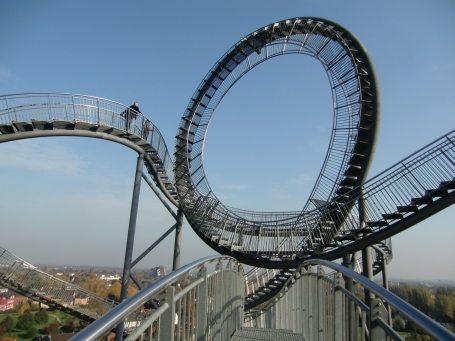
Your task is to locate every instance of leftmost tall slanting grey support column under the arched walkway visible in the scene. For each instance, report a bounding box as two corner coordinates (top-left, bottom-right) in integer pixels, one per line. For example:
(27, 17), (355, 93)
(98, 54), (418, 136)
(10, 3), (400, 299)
(115, 154), (144, 341)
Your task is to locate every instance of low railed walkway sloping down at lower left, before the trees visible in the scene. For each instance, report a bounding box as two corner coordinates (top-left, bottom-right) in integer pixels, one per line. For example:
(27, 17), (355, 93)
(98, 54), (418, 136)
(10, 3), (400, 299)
(0, 246), (116, 321)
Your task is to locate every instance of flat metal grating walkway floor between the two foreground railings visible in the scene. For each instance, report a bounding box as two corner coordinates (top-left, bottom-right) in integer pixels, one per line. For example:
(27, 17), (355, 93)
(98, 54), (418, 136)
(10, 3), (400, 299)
(231, 328), (305, 341)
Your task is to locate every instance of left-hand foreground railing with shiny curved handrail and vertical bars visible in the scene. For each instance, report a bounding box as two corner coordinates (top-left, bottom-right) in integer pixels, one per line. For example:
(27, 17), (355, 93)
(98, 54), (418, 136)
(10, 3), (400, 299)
(71, 256), (245, 341)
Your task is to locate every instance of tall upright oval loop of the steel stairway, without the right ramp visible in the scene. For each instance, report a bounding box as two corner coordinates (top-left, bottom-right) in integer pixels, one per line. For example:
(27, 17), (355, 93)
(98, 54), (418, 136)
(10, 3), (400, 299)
(174, 17), (380, 268)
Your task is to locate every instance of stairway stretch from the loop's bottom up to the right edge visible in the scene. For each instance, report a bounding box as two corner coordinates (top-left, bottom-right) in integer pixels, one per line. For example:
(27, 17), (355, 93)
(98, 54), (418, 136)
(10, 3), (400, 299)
(177, 131), (455, 268)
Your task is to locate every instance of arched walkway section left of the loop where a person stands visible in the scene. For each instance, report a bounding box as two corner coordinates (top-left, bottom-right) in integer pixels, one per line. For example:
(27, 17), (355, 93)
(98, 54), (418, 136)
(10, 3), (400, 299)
(0, 93), (178, 206)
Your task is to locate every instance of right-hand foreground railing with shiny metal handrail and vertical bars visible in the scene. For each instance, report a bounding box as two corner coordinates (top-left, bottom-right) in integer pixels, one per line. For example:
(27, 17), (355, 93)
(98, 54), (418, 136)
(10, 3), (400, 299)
(245, 260), (455, 341)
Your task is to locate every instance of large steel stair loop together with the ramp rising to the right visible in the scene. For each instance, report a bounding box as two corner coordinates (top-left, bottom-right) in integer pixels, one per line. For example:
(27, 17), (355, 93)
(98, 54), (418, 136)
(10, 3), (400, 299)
(174, 12), (455, 269)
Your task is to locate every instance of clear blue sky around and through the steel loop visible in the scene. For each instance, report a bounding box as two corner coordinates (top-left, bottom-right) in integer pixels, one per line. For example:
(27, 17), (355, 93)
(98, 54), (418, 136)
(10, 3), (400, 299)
(0, 0), (455, 280)
